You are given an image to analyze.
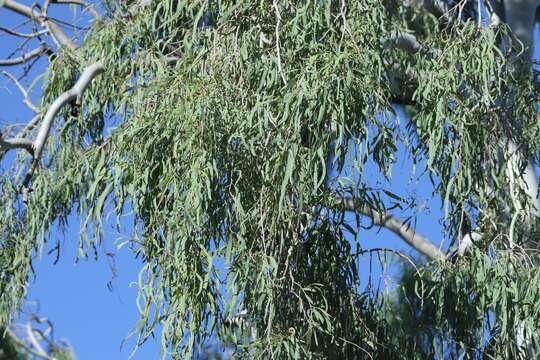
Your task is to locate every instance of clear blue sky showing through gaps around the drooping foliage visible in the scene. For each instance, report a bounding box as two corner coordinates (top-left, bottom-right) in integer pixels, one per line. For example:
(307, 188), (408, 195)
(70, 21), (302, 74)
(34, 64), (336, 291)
(0, 1), (539, 360)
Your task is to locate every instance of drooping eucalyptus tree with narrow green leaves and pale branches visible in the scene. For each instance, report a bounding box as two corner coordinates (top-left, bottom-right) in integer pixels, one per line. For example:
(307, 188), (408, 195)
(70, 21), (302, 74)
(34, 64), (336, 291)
(0, 0), (540, 359)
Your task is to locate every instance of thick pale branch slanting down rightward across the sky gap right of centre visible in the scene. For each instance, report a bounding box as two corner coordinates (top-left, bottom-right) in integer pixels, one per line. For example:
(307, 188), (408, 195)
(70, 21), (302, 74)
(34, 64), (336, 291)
(338, 197), (445, 260)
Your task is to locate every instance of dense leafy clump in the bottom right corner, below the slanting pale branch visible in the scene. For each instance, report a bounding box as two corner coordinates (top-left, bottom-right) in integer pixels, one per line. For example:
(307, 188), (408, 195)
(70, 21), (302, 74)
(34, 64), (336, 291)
(389, 248), (540, 359)
